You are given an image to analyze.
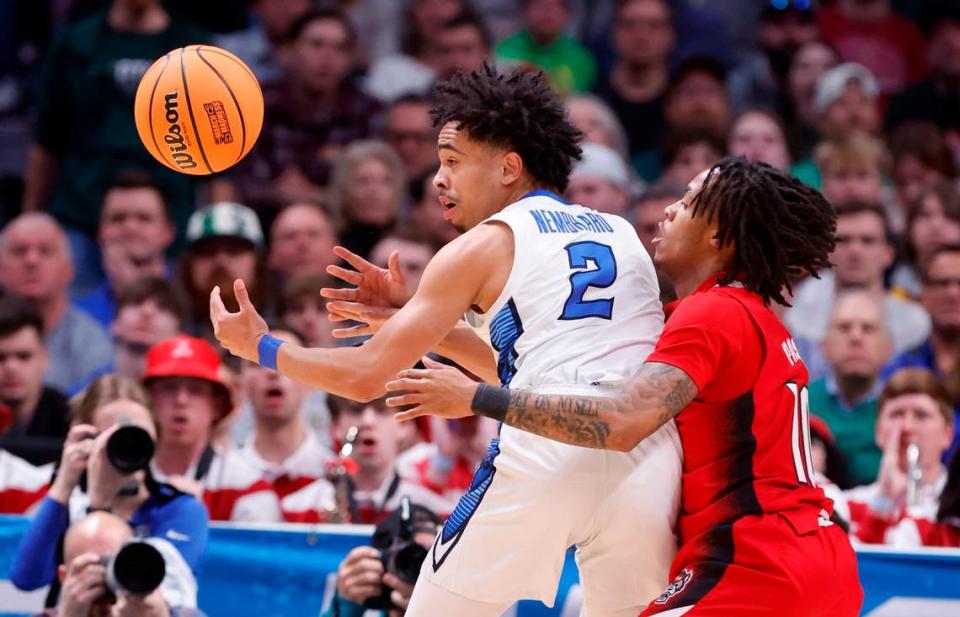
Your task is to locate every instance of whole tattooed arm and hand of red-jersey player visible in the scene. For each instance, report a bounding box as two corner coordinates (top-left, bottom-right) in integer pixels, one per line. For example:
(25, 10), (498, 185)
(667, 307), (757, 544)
(387, 362), (697, 451)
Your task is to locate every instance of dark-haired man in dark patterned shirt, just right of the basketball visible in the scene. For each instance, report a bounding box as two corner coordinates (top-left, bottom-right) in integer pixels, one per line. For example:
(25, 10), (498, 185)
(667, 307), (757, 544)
(235, 10), (380, 210)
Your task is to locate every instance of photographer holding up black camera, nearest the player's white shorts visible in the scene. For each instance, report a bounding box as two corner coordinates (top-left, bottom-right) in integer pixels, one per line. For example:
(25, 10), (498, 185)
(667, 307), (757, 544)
(321, 500), (440, 617)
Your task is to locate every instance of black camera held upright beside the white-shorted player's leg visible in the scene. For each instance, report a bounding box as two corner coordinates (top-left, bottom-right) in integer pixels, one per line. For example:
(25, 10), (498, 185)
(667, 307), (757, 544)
(363, 497), (440, 609)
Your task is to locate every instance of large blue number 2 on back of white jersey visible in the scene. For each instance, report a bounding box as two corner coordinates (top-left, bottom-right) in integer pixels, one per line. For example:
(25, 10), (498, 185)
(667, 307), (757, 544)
(560, 241), (617, 319)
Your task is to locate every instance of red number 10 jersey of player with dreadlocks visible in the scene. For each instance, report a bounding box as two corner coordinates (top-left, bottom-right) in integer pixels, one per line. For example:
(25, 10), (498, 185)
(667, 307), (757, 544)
(647, 277), (832, 545)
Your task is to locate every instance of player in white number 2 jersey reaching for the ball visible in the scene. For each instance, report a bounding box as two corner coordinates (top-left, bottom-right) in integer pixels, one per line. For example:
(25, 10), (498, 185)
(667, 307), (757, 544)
(211, 68), (680, 617)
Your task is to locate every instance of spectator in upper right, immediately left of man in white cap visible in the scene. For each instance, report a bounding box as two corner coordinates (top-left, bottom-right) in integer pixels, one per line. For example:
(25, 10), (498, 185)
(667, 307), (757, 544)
(784, 40), (839, 161)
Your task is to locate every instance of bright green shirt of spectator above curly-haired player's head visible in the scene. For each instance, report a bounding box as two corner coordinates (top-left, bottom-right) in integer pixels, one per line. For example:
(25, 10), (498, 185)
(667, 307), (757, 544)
(496, 30), (597, 95)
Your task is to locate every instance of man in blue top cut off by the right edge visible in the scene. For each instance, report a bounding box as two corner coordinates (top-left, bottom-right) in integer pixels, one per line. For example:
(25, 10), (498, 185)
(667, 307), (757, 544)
(884, 244), (960, 453)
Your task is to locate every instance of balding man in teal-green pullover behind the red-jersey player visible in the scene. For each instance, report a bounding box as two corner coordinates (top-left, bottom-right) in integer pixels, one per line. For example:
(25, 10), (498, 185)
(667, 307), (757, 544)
(800, 289), (893, 488)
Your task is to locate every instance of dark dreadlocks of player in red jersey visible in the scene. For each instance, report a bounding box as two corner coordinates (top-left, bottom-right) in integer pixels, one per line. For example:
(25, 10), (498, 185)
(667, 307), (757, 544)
(691, 157), (837, 306)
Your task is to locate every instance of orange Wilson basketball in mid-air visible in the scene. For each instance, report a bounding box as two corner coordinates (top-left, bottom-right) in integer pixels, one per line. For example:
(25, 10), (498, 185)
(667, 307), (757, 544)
(133, 45), (263, 176)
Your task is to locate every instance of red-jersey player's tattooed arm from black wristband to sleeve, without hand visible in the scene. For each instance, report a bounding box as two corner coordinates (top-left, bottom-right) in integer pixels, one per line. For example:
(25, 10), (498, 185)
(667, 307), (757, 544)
(472, 362), (697, 452)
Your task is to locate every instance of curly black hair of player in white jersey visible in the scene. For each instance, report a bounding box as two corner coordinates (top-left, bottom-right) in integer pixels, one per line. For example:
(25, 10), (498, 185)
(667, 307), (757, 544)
(430, 64), (583, 193)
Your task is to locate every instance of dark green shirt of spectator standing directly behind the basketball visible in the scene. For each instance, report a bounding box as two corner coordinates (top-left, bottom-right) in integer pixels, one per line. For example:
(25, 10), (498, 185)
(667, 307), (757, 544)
(36, 10), (207, 241)
